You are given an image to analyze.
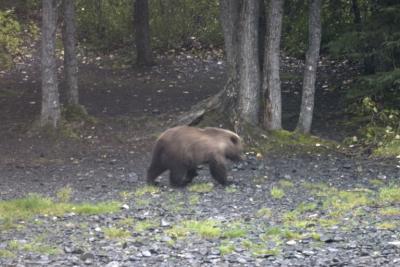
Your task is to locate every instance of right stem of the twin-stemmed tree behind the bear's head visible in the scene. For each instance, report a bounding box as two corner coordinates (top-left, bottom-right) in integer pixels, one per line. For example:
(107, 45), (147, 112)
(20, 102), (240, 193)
(238, 1), (260, 125)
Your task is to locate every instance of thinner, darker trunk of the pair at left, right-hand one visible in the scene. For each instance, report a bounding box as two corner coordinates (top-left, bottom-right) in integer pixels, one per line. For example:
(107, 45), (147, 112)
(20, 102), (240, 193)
(63, 0), (79, 105)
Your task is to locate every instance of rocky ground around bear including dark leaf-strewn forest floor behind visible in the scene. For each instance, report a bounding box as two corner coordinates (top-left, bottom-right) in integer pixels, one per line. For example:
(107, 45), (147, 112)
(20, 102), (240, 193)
(0, 52), (400, 267)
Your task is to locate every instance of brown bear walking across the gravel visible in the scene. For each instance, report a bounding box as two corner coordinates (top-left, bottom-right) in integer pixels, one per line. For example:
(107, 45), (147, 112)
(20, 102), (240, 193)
(147, 126), (243, 187)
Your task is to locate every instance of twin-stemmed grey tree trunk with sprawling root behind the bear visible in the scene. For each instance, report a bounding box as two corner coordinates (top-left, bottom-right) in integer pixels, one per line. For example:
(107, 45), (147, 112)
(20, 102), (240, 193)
(178, 0), (260, 133)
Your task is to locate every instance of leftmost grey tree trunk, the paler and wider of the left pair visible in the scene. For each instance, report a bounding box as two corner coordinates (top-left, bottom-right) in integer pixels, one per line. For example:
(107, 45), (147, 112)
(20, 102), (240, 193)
(40, 0), (61, 128)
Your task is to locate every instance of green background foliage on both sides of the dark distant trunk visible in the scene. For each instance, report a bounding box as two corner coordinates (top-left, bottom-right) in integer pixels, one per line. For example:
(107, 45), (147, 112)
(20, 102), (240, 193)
(76, 0), (223, 51)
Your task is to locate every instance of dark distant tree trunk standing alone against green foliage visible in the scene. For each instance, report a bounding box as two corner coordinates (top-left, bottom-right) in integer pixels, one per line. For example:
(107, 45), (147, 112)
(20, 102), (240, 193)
(134, 0), (153, 66)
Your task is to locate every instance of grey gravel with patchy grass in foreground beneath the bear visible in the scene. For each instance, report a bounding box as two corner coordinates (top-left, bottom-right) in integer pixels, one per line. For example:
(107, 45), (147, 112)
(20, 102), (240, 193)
(0, 149), (400, 267)
